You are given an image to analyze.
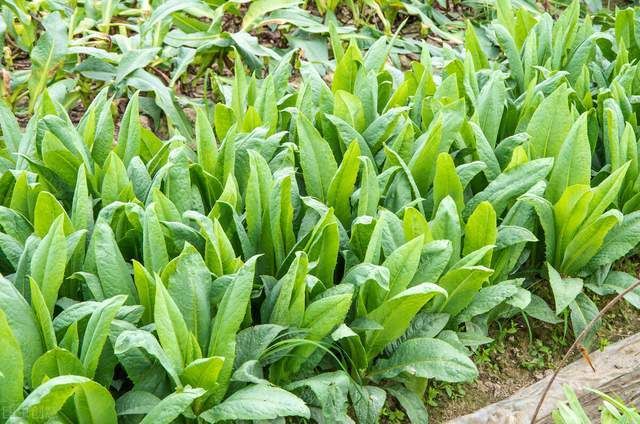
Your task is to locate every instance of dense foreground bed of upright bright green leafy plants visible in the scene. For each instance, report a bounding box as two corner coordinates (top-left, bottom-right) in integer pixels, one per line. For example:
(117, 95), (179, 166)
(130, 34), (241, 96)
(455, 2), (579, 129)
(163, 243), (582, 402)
(0, 2), (640, 423)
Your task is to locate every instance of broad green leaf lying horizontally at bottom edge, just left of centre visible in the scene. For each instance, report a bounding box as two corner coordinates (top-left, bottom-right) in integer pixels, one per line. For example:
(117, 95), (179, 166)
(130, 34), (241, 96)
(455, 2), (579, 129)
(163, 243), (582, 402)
(200, 384), (311, 423)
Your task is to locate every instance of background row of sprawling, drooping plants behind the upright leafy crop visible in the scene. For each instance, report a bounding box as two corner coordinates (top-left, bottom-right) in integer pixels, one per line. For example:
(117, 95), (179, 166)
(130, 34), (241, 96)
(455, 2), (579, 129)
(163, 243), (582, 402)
(0, 0), (490, 117)
